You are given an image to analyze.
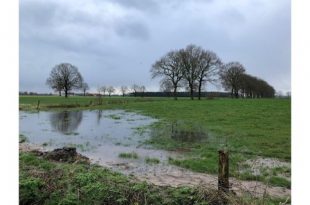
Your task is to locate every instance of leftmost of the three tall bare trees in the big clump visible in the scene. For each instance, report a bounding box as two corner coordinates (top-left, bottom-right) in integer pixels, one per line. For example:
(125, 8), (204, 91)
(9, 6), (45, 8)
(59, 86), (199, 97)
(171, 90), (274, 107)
(151, 51), (183, 100)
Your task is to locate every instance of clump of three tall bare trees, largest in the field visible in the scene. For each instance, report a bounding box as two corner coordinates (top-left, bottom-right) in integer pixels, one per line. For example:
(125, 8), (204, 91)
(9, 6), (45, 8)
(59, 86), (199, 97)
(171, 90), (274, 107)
(151, 44), (221, 100)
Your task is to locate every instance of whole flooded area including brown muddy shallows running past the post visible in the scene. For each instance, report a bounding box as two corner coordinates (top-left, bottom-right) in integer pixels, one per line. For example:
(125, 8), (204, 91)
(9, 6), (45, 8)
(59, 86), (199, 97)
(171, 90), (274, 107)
(19, 110), (290, 197)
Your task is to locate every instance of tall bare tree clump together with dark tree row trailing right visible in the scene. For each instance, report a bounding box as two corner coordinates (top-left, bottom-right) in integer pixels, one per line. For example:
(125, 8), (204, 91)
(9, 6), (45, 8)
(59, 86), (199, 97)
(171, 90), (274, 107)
(150, 44), (275, 100)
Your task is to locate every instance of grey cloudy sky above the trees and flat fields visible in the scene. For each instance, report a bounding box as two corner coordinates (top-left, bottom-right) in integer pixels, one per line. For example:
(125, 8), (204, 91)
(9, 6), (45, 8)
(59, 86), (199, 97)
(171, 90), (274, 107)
(19, 0), (291, 92)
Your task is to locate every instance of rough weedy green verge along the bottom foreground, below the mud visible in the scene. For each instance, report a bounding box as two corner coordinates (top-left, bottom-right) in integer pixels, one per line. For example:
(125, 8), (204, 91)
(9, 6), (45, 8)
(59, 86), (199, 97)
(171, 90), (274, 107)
(19, 153), (285, 205)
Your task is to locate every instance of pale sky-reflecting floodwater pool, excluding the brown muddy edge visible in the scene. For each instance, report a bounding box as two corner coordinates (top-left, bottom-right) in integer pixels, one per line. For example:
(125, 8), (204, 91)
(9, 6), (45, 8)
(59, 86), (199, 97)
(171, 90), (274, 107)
(19, 110), (178, 174)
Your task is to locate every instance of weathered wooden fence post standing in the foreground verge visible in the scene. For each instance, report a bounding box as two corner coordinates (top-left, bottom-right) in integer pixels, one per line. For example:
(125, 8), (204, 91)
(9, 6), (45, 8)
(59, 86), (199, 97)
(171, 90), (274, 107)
(218, 150), (229, 204)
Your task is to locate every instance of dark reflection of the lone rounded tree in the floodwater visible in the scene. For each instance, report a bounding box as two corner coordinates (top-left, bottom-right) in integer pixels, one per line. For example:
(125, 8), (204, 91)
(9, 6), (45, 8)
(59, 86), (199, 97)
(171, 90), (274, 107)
(50, 111), (83, 134)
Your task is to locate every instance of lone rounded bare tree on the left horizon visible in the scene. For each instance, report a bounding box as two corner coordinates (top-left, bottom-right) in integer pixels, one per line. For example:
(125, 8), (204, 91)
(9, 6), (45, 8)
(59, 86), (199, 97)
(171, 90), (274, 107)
(46, 63), (83, 98)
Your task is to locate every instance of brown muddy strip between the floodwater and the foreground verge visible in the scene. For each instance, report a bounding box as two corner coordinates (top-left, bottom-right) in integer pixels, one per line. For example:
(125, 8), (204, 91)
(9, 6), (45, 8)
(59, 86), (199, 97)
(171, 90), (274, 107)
(19, 143), (291, 198)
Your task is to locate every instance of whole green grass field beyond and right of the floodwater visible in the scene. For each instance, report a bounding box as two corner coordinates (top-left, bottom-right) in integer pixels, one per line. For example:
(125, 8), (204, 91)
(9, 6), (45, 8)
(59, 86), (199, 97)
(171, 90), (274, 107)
(20, 96), (291, 186)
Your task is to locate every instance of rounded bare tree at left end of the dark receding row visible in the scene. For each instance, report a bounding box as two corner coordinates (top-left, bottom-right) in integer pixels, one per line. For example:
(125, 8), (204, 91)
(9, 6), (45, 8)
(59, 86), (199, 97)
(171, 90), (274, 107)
(220, 62), (245, 98)
